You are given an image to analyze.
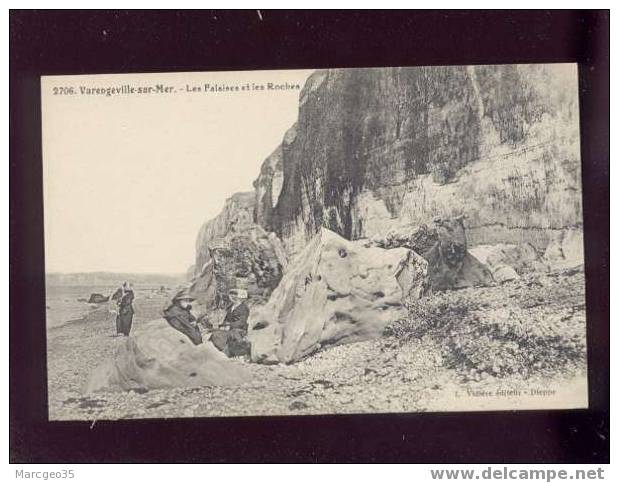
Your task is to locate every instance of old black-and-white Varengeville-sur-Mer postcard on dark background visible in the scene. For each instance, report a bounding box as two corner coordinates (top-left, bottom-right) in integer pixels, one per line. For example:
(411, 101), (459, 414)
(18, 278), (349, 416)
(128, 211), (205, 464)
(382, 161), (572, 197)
(41, 64), (588, 421)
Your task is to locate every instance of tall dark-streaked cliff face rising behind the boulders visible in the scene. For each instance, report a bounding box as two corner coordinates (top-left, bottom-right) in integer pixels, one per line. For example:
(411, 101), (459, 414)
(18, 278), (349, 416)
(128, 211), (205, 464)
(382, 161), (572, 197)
(196, 64), (582, 270)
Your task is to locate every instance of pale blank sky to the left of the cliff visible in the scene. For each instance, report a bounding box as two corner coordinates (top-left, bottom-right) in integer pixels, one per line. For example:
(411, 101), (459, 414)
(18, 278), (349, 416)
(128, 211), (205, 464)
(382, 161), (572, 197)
(41, 70), (312, 274)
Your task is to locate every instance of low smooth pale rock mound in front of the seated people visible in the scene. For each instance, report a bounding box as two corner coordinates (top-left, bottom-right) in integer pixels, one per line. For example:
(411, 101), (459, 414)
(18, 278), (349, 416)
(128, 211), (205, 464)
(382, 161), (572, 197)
(86, 319), (250, 393)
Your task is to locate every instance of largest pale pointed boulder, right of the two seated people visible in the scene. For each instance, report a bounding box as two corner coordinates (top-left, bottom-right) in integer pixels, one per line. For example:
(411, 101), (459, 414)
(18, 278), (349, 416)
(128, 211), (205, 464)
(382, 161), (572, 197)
(249, 228), (429, 363)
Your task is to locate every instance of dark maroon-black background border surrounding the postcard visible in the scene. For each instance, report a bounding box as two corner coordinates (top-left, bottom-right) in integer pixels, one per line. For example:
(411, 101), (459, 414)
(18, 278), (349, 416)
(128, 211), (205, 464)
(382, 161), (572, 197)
(9, 10), (610, 463)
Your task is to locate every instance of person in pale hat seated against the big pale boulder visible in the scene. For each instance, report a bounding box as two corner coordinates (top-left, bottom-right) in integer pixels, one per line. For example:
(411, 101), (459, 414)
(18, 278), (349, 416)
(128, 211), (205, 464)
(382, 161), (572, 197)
(211, 289), (250, 357)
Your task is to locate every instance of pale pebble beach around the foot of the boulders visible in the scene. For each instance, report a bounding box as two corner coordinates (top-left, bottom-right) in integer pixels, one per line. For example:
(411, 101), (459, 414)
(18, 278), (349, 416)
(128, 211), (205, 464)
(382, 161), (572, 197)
(47, 270), (586, 423)
